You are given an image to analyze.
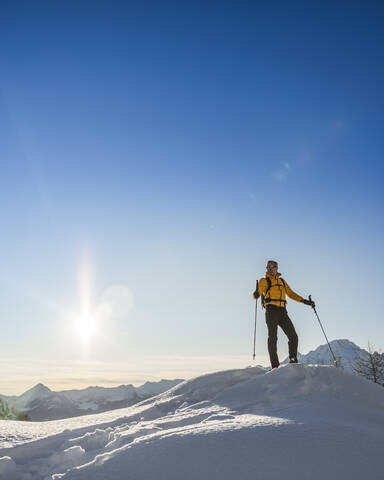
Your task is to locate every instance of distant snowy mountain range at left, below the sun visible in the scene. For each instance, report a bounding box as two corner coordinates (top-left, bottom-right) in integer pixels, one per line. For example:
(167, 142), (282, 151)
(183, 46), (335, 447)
(0, 379), (182, 421)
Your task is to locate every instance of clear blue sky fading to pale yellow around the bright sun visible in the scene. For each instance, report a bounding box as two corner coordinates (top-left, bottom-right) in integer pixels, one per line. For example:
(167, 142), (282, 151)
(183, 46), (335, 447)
(0, 0), (384, 394)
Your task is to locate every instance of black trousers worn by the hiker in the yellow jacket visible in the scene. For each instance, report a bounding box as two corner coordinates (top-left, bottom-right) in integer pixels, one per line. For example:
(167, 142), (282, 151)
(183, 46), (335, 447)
(265, 305), (298, 368)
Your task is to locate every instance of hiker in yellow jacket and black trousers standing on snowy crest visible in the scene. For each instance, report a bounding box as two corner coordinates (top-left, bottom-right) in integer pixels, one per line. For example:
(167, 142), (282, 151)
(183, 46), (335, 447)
(253, 260), (315, 368)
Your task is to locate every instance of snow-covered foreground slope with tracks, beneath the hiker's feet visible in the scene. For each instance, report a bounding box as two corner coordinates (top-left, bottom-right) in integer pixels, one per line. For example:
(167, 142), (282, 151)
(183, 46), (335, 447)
(0, 364), (384, 480)
